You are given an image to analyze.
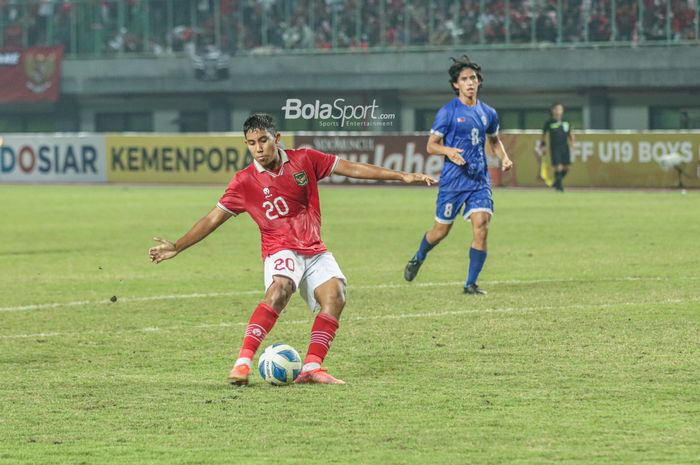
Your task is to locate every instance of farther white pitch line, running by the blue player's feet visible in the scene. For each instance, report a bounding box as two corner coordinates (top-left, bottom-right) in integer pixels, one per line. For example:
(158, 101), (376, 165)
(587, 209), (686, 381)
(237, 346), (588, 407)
(0, 276), (700, 312)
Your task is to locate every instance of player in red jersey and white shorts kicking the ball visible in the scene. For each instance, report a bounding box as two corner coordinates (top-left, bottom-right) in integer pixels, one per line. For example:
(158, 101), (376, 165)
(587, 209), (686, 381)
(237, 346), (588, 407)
(149, 113), (436, 385)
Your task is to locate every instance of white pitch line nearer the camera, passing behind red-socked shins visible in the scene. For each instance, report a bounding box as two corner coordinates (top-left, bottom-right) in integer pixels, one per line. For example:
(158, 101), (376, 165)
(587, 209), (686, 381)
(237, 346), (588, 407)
(0, 297), (700, 339)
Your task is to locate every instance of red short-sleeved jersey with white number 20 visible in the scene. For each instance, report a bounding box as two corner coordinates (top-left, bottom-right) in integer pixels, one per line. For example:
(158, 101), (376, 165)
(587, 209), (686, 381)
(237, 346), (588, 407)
(217, 149), (338, 259)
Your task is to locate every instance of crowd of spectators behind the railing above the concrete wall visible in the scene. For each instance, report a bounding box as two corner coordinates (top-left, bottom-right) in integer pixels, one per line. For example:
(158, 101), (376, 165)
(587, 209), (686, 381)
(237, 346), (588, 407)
(0, 0), (698, 54)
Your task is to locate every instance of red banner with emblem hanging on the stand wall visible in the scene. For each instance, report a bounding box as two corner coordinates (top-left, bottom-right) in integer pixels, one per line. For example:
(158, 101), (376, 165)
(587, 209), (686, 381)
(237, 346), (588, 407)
(0, 47), (63, 103)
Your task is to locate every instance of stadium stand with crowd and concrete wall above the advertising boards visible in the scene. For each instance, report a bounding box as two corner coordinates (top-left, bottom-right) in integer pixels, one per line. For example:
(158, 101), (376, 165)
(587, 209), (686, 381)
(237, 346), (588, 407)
(0, 0), (700, 132)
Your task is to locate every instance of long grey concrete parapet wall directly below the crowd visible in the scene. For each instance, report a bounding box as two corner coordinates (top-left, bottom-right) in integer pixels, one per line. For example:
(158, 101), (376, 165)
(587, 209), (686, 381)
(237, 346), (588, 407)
(62, 46), (700, 96)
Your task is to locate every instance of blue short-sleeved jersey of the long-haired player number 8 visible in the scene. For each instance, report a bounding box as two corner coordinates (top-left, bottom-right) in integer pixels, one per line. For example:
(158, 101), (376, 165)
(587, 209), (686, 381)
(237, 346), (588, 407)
(430, 98), (500, 192)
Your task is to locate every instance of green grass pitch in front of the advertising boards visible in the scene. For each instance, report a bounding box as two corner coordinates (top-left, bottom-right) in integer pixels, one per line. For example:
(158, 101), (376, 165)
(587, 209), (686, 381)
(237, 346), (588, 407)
(0, 186), (700, 465)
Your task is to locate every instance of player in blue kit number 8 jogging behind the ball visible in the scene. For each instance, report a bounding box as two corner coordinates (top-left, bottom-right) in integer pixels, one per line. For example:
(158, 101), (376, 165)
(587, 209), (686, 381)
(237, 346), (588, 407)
(404, 55), (513, 294)
